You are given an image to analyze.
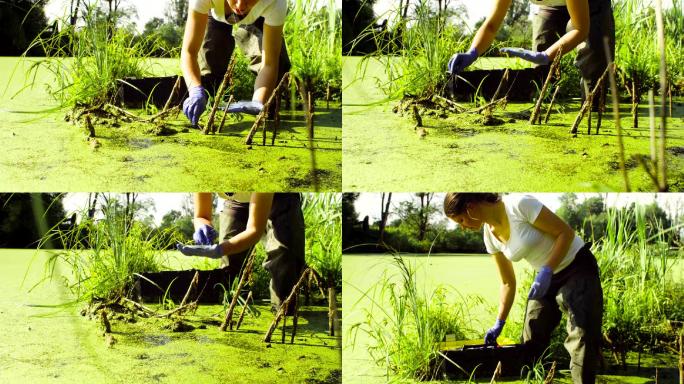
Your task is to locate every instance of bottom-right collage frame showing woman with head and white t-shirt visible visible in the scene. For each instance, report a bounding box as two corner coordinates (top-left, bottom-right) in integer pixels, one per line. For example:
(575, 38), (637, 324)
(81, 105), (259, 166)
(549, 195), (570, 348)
(342, 192), (684, 383)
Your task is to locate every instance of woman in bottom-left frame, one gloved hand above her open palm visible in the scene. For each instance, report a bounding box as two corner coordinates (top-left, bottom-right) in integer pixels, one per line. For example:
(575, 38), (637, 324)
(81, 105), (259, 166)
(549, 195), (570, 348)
(178, 192), (305, 308)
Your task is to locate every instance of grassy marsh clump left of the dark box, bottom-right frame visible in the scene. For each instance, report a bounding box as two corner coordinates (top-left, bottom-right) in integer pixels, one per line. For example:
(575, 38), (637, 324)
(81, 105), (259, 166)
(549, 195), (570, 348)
(349, 256), (481, 380)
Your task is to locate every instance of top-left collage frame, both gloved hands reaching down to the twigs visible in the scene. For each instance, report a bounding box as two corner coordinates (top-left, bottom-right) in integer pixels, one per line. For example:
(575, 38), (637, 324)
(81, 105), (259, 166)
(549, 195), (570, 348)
(0, 0), (342, 192)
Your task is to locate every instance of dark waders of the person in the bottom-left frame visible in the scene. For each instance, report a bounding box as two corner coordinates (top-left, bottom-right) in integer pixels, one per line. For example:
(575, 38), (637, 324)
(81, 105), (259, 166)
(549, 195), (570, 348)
(220, 193), (306, 308)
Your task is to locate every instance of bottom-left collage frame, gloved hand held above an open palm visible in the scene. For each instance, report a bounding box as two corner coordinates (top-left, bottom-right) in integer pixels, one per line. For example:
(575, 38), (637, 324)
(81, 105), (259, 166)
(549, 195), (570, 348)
(0, 192), (342, 383)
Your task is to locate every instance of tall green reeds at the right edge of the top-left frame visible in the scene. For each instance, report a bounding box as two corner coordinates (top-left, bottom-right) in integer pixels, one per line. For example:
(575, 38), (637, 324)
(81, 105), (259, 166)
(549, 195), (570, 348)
(284, 0), (342, 105)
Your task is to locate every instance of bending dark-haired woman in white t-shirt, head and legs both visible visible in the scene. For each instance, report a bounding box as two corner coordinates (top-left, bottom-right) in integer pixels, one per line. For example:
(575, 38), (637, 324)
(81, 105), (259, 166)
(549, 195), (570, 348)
(444, 193), (603, 383)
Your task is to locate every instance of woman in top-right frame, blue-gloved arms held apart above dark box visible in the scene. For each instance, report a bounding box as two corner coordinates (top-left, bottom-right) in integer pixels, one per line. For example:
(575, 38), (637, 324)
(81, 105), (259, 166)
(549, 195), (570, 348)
(449, 0), (615, 103)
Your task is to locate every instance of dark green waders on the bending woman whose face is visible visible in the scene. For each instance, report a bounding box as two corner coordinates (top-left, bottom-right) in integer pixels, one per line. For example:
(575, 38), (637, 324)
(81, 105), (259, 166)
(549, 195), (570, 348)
(523, 244), (603, 384)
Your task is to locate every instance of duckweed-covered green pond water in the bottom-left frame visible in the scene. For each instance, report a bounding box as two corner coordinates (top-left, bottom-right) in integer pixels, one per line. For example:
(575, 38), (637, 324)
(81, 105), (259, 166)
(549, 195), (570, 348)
(0, 249), (341, 383)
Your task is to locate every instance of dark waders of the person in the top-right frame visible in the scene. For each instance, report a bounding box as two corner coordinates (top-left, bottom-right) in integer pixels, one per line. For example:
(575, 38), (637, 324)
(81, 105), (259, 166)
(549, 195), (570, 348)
(532, 0), (615, 106)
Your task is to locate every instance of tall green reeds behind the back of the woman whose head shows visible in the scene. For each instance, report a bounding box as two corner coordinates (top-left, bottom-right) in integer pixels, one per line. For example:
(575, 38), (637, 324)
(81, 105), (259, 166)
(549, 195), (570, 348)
(595, 205), (684, 363)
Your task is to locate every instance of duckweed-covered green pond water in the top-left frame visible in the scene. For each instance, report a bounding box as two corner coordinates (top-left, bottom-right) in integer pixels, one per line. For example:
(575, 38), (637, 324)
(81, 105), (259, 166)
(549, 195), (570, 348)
(0, 57), (342, 192)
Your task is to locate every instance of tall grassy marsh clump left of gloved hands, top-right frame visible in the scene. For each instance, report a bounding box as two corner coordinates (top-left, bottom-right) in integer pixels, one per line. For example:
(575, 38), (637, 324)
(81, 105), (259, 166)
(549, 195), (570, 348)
(355, 0), (470, 99)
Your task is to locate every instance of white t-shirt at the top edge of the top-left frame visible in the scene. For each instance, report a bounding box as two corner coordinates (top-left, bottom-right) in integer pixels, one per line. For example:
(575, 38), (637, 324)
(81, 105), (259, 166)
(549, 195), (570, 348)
(189, 0), (287, 27)
